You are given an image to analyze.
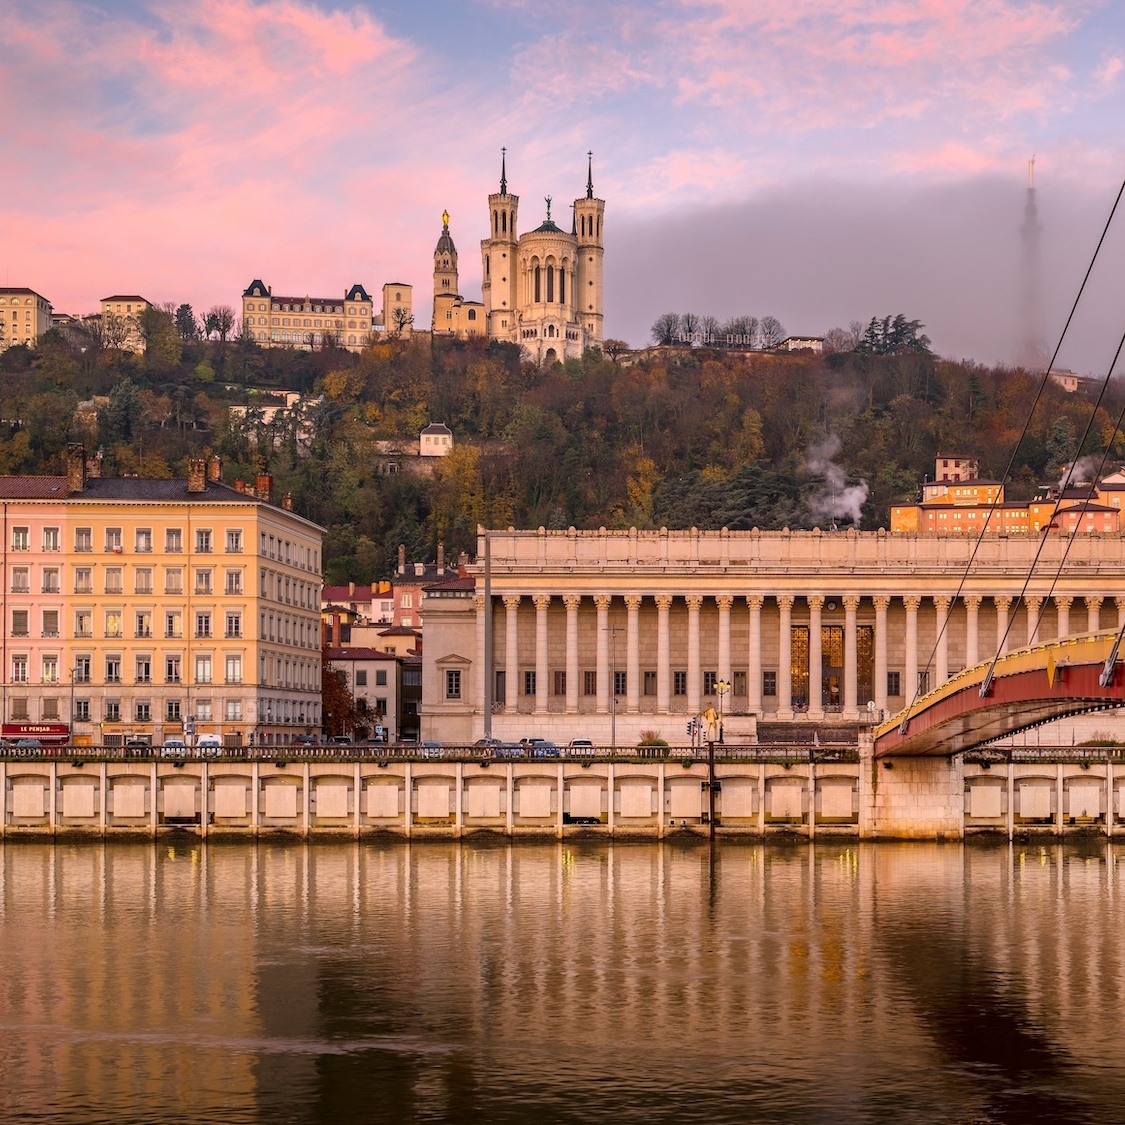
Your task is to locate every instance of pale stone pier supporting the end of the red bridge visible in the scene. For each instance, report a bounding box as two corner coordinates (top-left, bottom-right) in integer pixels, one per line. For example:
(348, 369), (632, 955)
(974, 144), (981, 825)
(860, 736), (965, 840)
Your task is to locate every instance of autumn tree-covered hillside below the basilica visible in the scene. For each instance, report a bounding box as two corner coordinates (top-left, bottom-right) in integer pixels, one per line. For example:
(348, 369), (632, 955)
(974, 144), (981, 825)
(0, 307), (1123, 582)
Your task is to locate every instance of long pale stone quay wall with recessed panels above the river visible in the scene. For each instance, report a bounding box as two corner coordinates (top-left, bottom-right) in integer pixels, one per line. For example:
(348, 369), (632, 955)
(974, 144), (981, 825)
(0, 744), (1125, 840)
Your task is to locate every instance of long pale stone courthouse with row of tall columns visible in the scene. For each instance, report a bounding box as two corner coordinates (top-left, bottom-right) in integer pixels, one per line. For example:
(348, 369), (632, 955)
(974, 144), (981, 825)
(422, 528), (1125, 746)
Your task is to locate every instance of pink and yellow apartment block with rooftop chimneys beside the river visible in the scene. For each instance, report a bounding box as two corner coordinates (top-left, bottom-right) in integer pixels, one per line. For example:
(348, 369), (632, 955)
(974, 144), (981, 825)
(0, 446), (322, 746)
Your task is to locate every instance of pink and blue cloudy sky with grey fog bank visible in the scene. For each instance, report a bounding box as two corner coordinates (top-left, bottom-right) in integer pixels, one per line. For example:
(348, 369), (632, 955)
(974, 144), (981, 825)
(0, 0), (1125, 369)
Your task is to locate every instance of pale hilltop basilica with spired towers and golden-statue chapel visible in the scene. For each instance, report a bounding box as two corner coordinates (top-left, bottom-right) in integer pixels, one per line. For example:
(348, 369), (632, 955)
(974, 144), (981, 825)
(432, 154), (605, 362)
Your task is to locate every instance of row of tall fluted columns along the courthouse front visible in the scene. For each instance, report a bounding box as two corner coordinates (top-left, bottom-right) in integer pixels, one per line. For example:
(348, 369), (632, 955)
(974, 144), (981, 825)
(475, 592), (1125, 719)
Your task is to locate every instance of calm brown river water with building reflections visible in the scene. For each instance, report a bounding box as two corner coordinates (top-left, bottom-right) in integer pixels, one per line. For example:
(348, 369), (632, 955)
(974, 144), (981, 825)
(0, 842), (1125, 1125)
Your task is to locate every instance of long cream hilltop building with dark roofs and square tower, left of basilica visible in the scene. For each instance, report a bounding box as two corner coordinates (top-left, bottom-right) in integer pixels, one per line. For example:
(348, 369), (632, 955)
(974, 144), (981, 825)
(242, 278), (414, 352)
